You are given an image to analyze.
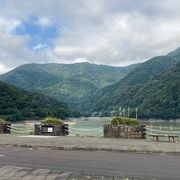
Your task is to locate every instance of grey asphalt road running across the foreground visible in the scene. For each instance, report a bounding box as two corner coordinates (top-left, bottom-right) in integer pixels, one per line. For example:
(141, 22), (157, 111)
(0, 147), (180, 180)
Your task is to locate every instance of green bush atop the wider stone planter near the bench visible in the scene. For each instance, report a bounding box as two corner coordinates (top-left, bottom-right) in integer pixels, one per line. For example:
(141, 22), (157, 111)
(111, 117), (139, 126)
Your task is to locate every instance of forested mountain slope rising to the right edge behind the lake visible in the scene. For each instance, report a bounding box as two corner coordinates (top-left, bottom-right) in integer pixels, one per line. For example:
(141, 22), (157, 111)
(90, 49), (180, 118)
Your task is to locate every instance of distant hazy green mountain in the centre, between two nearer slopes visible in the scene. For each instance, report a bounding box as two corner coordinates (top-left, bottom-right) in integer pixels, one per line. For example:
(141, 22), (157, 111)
(0, 63), (139, 109)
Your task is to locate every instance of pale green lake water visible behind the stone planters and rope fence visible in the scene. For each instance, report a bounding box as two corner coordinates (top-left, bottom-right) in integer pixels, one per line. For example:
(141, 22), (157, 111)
(12, 117), (180, 137)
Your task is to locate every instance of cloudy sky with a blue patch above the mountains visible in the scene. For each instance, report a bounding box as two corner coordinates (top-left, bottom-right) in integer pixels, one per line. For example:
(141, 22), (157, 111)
(0, 0), (180, 74)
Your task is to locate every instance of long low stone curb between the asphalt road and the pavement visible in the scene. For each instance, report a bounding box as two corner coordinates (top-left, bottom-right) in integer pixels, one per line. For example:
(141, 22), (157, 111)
(0, 144), (180, 156)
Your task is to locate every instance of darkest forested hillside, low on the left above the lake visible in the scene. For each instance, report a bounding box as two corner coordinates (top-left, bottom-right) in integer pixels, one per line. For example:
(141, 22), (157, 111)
(0, 81), (70, 121)
